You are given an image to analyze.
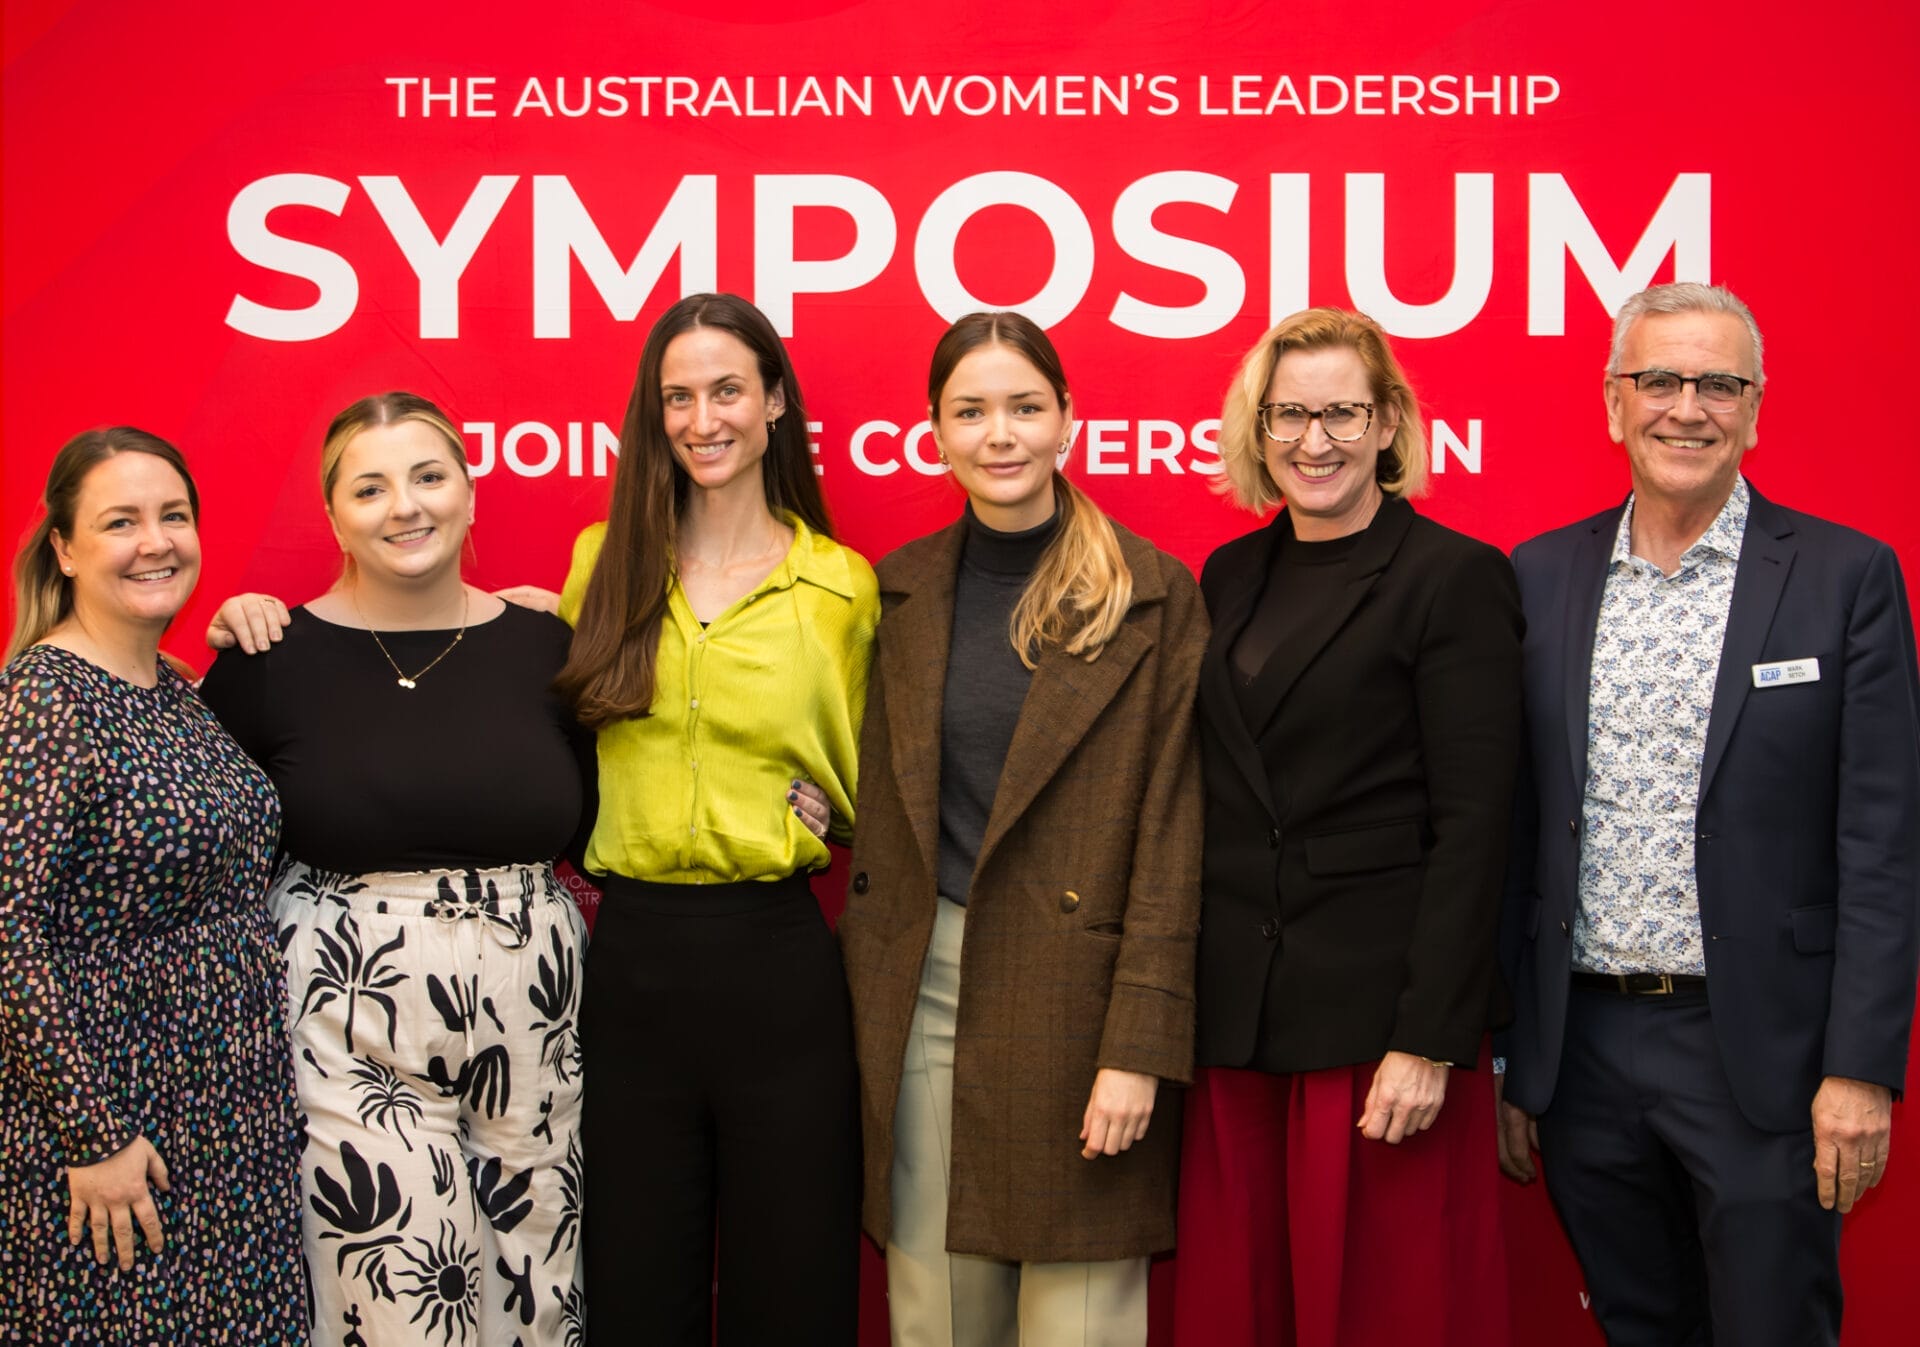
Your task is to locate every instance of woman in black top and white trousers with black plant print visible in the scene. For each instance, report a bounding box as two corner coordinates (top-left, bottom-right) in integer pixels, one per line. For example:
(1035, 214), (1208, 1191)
(204, 393), (593, 1347)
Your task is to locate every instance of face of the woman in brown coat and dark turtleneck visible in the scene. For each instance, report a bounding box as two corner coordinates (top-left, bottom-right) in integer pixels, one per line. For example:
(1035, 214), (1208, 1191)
(927, 343), (1073, 533)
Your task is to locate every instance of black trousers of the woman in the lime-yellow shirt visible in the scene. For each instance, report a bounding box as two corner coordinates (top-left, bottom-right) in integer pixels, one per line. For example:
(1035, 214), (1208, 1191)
(580, 875), (860, 1347)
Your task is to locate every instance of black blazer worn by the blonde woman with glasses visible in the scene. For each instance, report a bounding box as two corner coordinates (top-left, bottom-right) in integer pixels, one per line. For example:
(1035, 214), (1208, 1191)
(1198, 497), (1521, 1073)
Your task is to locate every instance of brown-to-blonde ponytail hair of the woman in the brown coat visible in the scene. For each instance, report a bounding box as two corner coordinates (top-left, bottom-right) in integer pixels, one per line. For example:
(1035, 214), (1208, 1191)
(927, 313), (1133, 670)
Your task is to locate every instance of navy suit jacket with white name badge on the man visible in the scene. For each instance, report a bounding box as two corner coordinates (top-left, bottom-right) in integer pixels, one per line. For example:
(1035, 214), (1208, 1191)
(1501, 479), (1920, 1132)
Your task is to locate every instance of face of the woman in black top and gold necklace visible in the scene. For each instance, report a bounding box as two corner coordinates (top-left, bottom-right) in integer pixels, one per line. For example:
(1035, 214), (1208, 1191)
(326, 420), (474, 583)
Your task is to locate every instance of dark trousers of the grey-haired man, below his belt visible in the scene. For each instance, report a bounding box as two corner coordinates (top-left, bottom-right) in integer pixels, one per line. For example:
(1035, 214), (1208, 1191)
(1540, 986), (1841, 1347)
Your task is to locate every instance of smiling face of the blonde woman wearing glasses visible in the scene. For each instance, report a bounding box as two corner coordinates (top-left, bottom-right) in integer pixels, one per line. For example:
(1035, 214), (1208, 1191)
(1261, 345), (1400, 541)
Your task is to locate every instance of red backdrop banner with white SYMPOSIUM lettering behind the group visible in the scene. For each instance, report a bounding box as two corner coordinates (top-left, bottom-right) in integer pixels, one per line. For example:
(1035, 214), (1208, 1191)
(11, 0), (1920, 1347)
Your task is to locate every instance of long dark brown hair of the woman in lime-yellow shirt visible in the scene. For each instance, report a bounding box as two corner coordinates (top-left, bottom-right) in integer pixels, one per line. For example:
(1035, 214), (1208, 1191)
(555, 294), (833, 729)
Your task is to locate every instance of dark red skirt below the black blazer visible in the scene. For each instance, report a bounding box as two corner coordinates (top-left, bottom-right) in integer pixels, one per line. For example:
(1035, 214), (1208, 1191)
(1173, 1061), (1509, 1347)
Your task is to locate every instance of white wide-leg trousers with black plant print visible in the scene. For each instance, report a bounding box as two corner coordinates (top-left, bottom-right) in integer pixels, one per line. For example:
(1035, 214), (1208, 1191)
(271, 863), (586, 1347)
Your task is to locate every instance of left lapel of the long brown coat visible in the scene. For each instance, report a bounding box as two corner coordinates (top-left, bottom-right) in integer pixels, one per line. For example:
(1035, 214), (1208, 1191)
(877, 524), (964, 875)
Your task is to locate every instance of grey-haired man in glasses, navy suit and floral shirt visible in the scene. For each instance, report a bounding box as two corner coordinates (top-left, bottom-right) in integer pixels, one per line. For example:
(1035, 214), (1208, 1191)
(1500, 284), (1920, 1347)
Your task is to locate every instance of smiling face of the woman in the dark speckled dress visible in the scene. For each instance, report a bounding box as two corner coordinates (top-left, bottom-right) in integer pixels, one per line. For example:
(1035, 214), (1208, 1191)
(50, 453), (200, 631)
